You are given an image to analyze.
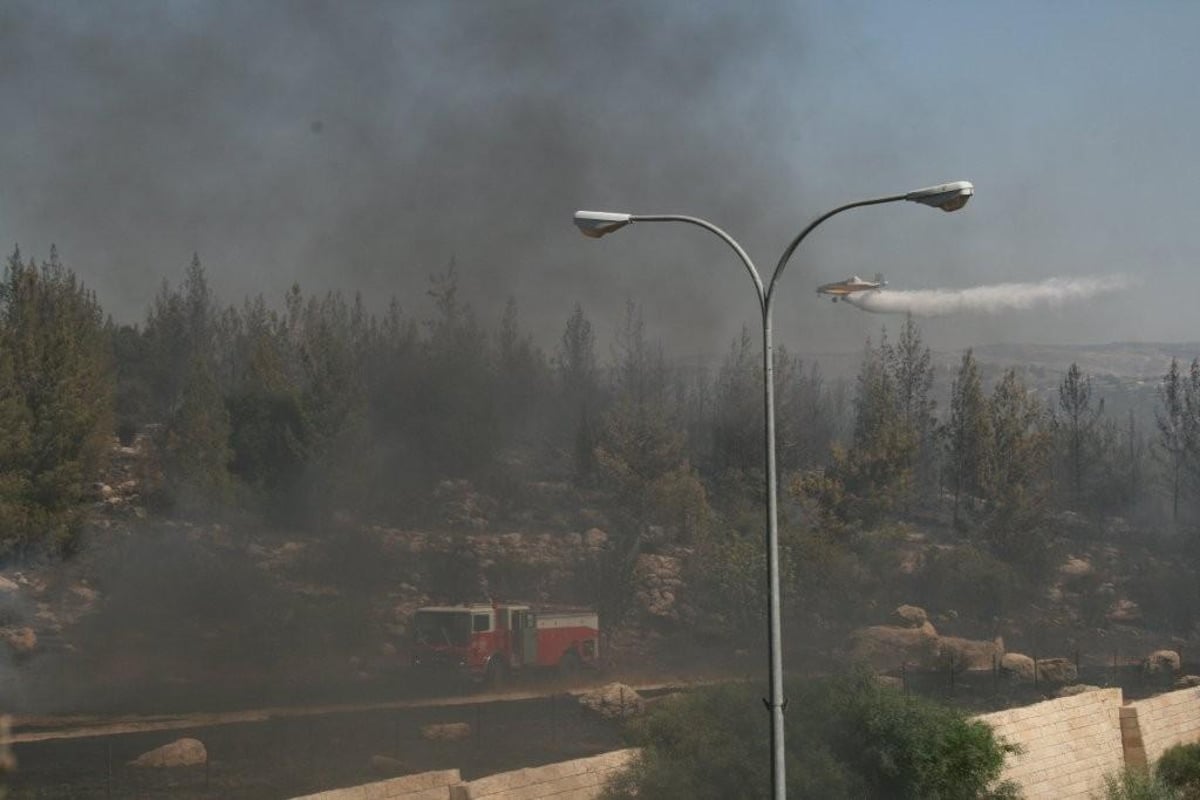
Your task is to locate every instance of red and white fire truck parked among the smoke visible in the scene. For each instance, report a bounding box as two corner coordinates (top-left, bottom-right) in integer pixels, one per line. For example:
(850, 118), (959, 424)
(412, 603), (600, 685)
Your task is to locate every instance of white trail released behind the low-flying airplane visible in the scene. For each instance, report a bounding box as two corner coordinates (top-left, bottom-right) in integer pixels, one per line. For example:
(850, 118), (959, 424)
(846, 275), (1133, 317)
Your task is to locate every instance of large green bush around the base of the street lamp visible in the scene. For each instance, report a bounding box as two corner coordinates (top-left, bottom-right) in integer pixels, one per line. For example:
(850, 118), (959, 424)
(605, 673), (1016, 800)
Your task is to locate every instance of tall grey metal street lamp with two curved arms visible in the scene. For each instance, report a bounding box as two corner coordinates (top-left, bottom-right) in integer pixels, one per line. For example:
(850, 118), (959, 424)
(575, 181), (974, 800)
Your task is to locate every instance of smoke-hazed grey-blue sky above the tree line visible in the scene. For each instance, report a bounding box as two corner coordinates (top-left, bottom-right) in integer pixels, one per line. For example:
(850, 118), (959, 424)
(0, 0), (1200, 353)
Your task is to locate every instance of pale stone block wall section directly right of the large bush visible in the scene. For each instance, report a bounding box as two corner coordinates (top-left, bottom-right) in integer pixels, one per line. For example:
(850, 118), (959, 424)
(977, 688), (1124, 800)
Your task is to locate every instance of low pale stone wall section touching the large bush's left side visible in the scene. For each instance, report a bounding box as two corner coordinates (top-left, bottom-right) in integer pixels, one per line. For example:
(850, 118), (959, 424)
(450, 750), (637, 800)
